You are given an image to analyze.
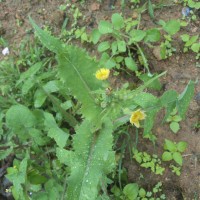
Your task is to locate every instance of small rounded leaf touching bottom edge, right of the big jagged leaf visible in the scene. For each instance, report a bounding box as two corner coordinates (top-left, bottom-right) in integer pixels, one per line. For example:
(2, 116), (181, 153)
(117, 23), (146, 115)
(123, 183), (139, 200)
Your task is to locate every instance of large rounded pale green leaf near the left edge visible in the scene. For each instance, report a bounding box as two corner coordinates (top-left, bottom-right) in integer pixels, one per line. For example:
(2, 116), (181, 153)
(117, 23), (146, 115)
(6, 105), (36, 130)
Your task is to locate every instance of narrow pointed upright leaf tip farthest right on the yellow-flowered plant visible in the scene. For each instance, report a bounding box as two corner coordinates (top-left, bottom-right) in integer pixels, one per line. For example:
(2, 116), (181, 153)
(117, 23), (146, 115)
(177, 81), (195, 119)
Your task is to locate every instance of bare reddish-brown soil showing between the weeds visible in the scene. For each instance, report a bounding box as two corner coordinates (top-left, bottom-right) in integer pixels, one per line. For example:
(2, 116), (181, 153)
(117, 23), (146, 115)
(0, 0), (200, 200)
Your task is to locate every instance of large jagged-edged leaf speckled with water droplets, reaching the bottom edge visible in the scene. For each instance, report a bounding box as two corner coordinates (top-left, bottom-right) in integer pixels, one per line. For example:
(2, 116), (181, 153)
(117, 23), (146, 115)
(59, 119), (115, 200)
